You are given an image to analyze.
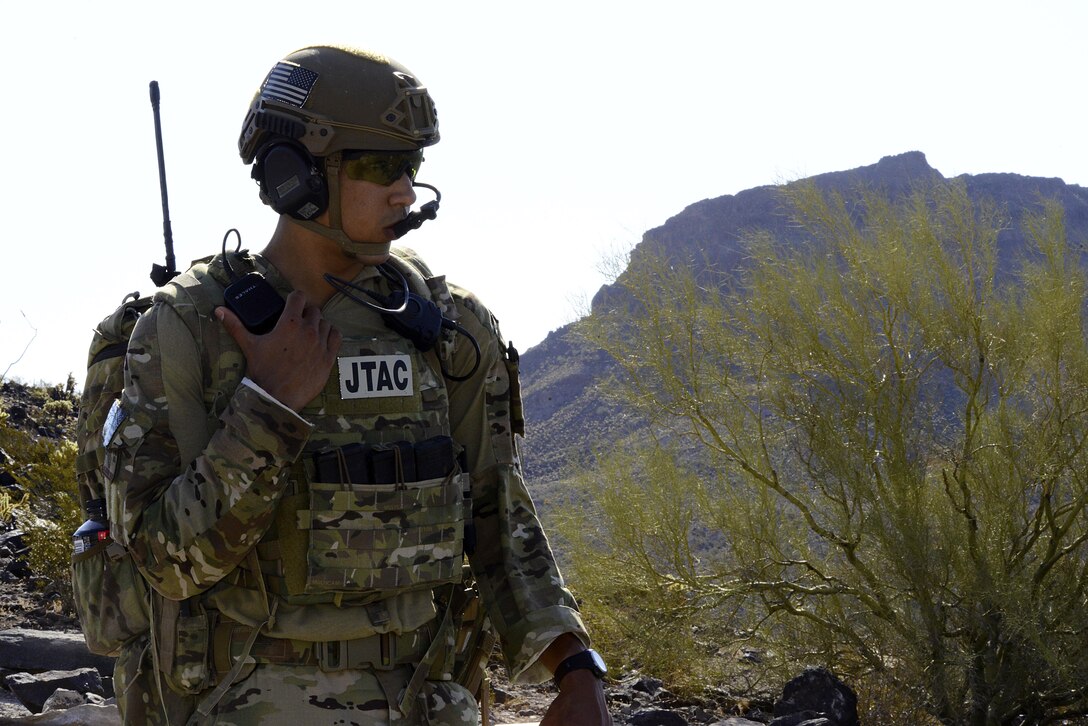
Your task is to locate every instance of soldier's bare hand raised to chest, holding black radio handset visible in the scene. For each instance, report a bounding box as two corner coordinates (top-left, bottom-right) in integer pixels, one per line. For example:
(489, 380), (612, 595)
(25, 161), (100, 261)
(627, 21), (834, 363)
(215, 291), (341, 411)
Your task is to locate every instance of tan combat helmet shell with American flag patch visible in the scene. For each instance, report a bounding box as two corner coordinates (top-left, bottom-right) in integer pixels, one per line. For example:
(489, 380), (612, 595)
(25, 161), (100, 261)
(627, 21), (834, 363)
(238, 46), (438, 164)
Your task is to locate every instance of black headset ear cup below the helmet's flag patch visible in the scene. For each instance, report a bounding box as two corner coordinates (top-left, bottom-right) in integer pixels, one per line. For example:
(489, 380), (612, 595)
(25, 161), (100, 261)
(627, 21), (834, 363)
(254, 141), (329, 220)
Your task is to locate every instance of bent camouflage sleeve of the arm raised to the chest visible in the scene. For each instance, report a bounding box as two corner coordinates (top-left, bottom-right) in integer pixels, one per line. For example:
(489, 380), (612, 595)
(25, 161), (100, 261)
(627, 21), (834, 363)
(107, 302), (310, 600)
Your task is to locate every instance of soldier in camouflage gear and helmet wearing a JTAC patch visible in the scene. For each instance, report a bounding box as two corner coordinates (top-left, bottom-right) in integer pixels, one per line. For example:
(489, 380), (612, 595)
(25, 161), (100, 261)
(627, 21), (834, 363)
(103, 47), (610, 725)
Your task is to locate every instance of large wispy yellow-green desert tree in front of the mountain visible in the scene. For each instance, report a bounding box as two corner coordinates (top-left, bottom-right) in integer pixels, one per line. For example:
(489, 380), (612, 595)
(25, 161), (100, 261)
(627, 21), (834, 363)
(565, 183), (1088, 726)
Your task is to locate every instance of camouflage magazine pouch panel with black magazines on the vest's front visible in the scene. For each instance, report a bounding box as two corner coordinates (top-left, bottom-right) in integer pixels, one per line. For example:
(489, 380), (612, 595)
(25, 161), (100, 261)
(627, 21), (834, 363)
(237, 436), (469, 604)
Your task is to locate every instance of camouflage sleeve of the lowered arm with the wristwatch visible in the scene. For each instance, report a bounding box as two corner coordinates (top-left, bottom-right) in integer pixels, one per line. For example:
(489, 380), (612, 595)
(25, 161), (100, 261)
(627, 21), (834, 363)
(449, 291), (590, 682)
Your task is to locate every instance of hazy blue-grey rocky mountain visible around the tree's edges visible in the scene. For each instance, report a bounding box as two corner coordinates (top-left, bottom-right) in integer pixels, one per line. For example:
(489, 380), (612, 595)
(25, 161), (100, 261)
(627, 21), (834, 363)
(521, 151), (1088, 491)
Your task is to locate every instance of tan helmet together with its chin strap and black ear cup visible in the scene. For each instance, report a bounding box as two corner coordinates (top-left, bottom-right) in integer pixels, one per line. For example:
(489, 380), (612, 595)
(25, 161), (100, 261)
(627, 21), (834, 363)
(238, 46), (440, 255)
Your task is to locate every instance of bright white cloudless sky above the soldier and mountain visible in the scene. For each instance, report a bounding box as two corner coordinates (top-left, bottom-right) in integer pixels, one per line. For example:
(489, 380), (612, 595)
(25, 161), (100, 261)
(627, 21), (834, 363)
(0, 0), (1088, 385)
